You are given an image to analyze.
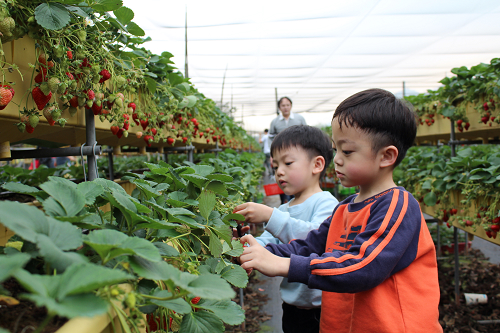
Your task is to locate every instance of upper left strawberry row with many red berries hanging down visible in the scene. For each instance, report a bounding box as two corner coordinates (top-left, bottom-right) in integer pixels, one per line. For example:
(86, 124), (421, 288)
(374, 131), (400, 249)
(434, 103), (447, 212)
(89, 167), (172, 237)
(0, 0), (258, 149)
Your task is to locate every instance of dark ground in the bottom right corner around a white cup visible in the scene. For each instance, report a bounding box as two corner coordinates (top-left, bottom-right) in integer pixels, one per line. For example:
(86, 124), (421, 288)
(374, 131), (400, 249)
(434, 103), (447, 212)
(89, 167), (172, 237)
(439, 249), (500, 333)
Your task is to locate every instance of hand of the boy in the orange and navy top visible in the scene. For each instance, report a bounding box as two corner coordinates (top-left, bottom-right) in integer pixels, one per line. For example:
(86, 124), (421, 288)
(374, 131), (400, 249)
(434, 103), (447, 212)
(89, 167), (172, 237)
(239, 235), (290, 277)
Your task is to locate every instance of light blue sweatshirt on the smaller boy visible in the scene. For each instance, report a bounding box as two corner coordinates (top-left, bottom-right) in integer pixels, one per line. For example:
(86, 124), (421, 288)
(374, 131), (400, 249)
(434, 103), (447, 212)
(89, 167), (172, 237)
(256, 191), (339, 308)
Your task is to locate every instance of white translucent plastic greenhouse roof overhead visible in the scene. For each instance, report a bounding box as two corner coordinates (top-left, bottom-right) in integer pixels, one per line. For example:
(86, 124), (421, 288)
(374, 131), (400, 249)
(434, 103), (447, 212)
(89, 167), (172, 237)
(123, 0), (500, 130)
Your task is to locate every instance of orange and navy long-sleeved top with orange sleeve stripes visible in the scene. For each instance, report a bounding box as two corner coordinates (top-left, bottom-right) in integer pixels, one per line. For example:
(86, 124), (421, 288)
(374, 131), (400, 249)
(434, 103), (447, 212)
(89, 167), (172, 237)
(266, 187), (443, 333)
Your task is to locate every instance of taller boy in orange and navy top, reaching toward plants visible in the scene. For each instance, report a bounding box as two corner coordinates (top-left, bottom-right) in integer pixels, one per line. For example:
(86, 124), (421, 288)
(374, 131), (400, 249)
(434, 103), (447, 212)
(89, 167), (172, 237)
(240, 89), (443, 333)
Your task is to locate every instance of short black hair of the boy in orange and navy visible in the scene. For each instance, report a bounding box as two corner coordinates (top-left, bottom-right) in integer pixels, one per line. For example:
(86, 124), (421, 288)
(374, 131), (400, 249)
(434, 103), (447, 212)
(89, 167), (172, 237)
(332, 89), (417, 167)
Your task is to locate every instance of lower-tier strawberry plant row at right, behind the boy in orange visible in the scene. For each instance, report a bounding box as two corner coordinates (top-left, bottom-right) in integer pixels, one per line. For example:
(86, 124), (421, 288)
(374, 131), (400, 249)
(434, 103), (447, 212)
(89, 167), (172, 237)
(395, 145), (500, 243)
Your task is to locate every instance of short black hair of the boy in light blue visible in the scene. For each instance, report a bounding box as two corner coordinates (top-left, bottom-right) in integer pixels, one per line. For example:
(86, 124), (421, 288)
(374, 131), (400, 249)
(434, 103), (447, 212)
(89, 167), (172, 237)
(271, 125), (333, 178)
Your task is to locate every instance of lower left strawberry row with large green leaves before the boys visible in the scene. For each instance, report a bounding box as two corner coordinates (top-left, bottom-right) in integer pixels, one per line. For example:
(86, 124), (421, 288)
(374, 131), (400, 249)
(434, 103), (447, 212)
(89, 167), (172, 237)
(0, 152), (268, 332)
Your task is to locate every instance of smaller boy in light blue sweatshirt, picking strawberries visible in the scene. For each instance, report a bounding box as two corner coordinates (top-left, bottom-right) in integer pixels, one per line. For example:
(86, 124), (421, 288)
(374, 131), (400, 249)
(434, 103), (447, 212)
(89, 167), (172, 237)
(234, 125), (338, 333)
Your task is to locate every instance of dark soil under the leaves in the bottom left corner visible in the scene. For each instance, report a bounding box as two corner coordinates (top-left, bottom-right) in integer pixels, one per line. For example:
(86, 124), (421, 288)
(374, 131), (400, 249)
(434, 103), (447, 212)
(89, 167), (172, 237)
(0, 279), (68, 333)
